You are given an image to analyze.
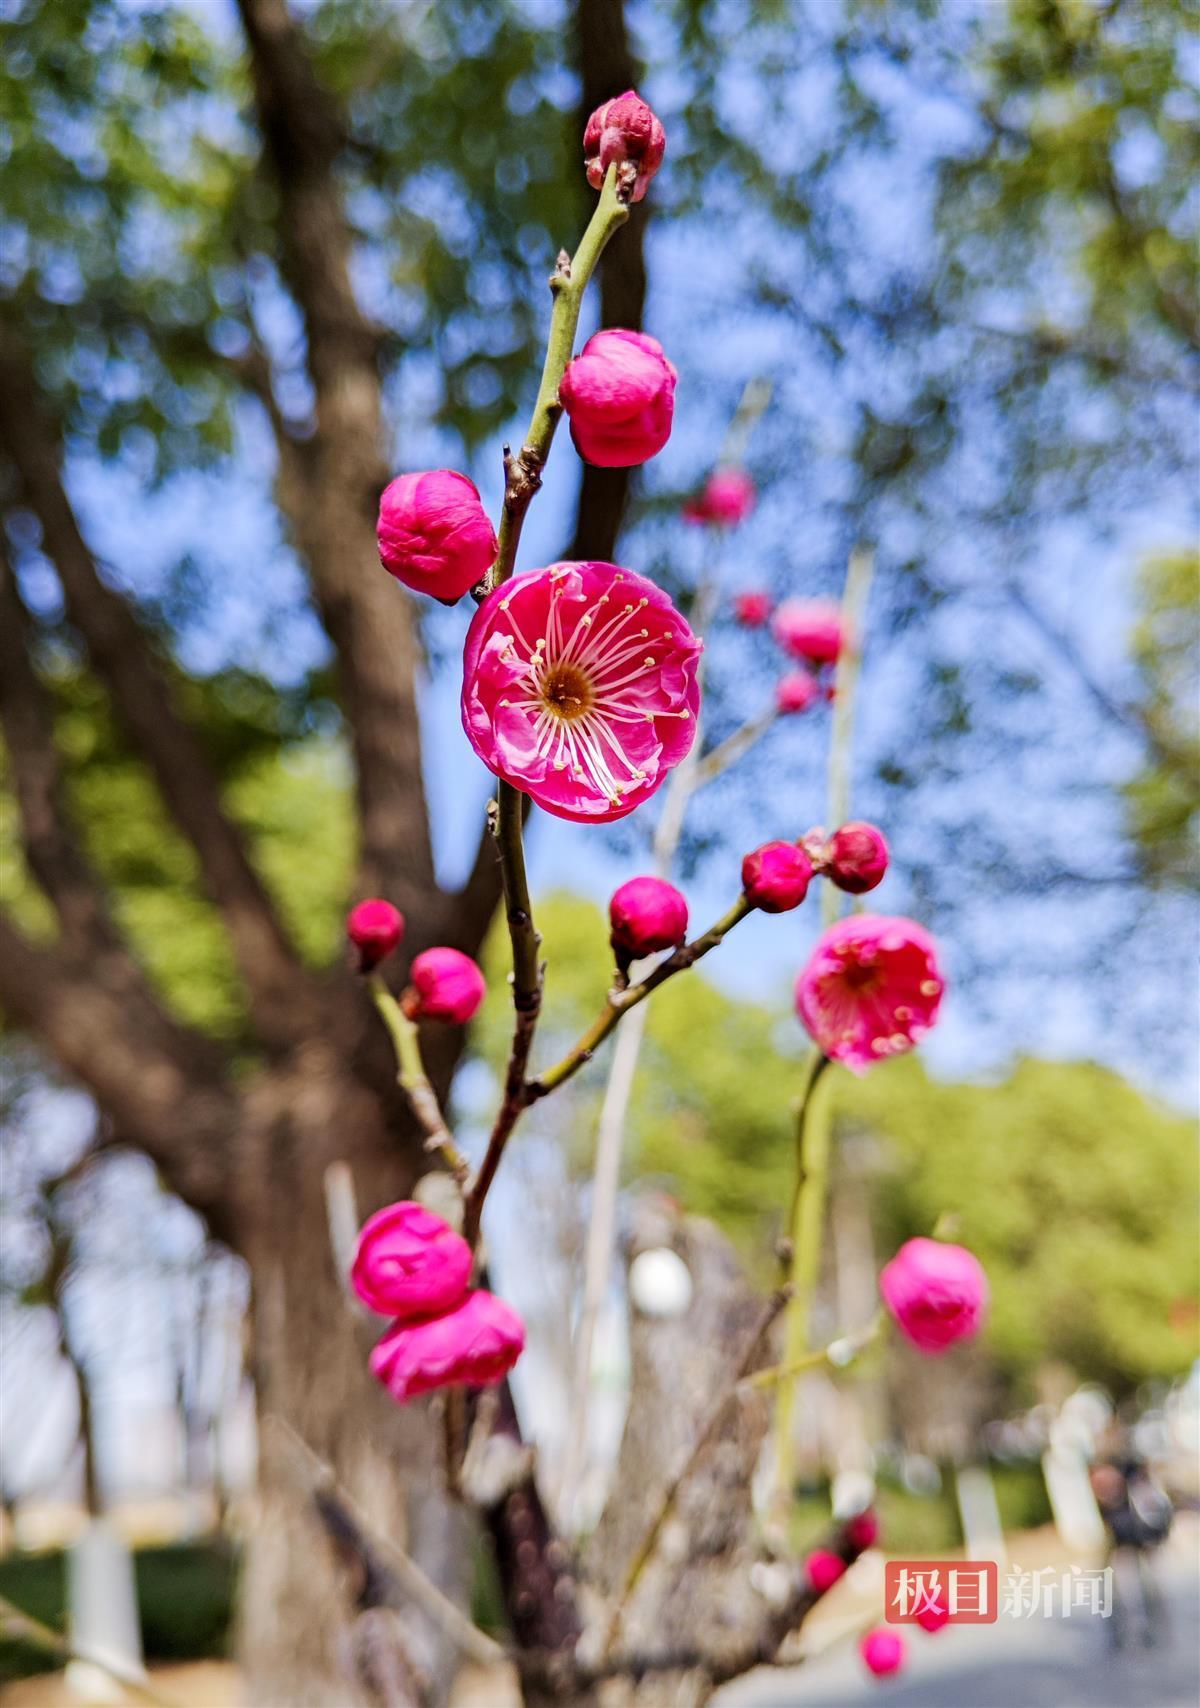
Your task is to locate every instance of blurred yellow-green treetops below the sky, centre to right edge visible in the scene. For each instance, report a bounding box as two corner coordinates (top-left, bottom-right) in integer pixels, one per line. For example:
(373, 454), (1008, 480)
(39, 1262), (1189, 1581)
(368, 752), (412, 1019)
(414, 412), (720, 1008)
(480, 895), (1200, 1390)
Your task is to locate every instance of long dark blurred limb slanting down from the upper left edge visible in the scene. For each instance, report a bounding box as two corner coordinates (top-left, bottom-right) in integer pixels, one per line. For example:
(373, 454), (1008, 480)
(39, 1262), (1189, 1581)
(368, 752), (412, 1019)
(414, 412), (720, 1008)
(0, 343), (317, 1044)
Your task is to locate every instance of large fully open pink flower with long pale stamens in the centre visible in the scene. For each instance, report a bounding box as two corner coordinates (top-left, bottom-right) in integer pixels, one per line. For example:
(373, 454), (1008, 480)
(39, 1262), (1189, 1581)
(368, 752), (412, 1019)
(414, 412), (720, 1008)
(463, 562), (702, 823)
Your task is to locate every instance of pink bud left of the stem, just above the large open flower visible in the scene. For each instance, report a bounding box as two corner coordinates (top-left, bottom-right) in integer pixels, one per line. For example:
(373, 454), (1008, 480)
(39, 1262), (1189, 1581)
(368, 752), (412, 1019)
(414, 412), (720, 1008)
(377, 468), (497, 605)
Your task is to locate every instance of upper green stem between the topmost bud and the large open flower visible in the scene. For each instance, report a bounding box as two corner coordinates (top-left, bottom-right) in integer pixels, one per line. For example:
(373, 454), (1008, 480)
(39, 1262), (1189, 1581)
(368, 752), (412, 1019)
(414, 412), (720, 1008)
(488, 166), (630, 588)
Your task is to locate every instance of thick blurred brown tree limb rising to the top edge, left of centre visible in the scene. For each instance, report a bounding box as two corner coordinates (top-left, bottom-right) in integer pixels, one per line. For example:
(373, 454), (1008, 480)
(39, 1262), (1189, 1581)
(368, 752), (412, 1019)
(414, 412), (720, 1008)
(239, 0), (435, 922)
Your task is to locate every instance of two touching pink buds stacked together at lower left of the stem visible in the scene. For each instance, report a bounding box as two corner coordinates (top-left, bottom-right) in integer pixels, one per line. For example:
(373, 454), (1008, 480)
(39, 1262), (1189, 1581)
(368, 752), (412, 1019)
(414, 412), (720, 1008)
(350, 1199), (526, 1406)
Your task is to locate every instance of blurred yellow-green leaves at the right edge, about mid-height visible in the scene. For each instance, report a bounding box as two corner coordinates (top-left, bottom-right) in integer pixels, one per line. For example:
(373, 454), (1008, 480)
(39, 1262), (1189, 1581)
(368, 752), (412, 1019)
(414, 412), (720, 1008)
(1125, 552), (1200, 886)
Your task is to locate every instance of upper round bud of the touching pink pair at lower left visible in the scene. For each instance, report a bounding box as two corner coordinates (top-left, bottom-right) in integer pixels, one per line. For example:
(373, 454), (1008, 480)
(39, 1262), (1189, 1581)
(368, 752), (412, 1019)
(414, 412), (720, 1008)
(350, 1199), (471, 1317)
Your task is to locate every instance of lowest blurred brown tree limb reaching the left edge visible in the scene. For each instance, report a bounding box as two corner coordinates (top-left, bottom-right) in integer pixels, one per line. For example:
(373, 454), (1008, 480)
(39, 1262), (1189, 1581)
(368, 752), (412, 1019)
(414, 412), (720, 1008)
(0, 914), (237, 1209)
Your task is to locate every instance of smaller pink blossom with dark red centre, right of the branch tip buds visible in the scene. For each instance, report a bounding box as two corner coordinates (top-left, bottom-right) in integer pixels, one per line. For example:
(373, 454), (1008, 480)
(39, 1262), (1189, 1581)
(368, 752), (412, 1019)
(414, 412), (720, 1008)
(795, 914), (946, 1073)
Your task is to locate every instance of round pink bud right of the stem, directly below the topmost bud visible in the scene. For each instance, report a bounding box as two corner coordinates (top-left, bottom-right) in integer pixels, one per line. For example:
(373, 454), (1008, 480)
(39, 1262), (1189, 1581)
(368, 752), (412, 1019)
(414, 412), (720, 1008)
(558, 330), (678, 468)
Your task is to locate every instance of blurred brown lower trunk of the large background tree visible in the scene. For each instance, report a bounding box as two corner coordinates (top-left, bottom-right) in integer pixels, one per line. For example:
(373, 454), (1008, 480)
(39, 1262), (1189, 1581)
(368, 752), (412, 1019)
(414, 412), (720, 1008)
(227, 1050), (471, 1708)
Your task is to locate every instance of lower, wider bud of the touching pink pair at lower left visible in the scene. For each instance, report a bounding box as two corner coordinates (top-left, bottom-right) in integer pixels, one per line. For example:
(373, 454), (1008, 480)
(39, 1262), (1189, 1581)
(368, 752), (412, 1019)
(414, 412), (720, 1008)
(370, 1288), (526, 1406)
